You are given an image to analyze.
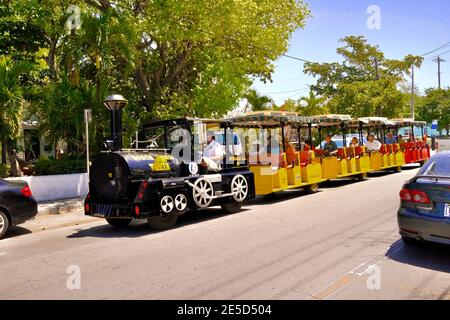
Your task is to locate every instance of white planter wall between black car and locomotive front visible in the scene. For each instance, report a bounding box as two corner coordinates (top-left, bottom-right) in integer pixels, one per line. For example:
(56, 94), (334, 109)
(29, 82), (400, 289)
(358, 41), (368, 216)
(6, 173), (89, 202)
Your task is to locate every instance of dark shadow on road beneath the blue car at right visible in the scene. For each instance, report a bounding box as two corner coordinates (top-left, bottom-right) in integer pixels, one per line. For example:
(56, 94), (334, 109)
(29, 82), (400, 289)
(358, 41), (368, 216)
(386, 240), (450, 273)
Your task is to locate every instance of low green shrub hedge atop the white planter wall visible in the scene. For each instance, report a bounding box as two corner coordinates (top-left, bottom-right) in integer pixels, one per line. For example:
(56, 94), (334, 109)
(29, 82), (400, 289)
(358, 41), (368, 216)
(34, 159), (86, 176)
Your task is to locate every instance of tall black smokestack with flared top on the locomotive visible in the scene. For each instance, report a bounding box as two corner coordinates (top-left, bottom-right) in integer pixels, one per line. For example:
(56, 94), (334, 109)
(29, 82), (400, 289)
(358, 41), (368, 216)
(103, 94), (128, 151)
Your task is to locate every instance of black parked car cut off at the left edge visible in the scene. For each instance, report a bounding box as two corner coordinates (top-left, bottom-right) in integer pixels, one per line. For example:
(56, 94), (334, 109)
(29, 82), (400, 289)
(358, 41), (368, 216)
(0, 179), (38, 239)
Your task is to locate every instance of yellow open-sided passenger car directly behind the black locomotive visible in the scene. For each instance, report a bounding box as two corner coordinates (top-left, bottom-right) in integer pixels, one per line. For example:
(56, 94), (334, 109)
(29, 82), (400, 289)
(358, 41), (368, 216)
(232, 111), (325, 195)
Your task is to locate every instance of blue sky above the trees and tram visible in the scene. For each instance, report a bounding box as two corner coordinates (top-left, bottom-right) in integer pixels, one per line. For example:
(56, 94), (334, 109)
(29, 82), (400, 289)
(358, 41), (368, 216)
(253, 0), (450, 105)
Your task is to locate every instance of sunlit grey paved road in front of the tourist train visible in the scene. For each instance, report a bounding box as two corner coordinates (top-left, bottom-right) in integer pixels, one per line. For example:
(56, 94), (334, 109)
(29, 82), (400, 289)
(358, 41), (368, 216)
(0, 162), (450, 299)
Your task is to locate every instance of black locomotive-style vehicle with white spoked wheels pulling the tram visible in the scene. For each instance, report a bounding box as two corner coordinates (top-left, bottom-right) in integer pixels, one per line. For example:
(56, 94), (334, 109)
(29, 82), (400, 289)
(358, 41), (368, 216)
(85, 96), (255, 230)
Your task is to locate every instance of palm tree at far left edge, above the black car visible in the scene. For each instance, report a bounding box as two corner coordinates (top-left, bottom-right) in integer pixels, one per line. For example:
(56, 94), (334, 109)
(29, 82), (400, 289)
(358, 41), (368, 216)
(0, 56), (33, 176)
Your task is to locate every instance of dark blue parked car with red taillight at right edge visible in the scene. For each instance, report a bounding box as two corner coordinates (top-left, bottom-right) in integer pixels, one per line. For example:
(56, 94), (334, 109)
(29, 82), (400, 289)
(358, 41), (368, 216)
(397, 151), (450, 244)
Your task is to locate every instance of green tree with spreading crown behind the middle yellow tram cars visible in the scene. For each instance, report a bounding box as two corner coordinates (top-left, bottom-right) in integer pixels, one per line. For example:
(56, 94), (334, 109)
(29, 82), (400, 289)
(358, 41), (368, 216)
(305, 36), (423, 117)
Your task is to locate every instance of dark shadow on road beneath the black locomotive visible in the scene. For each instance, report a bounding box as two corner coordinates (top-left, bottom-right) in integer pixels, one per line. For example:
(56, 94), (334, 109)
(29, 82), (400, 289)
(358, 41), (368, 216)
(67, 207), (247, 238)
